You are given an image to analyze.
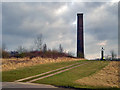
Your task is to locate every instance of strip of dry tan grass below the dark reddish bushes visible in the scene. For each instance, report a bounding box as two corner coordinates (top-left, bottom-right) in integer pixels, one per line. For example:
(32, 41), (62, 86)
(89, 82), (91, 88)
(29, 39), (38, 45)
(2, 57), (84, 71)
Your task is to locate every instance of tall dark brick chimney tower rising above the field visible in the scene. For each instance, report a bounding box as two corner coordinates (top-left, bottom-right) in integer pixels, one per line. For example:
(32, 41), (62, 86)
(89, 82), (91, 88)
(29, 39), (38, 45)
(77, 13), (84, 58)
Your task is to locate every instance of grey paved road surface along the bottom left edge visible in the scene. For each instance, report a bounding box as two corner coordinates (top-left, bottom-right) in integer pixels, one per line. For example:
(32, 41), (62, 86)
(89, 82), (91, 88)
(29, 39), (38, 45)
(0, 82), (76, 90)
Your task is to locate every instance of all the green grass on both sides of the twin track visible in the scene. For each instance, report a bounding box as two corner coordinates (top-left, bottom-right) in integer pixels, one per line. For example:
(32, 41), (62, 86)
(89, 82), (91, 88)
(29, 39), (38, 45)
(2, 60), (109, 88)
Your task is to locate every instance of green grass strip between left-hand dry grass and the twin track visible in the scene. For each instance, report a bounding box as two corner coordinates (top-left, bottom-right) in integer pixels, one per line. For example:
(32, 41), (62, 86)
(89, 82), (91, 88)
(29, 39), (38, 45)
(2, 61), (86, 81)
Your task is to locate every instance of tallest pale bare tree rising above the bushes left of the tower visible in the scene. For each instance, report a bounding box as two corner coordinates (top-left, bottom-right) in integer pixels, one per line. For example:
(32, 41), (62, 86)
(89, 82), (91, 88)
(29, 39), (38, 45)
(34, 34), (43, 51)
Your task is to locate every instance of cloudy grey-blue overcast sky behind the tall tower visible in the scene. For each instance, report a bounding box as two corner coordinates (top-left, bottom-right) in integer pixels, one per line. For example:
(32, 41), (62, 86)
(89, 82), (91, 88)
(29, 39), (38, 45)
(2, 2), (118, 59)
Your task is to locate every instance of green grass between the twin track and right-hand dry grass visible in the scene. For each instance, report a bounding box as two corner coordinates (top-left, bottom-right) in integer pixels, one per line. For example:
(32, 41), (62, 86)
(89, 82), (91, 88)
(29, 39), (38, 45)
(34, 61), (109, 88)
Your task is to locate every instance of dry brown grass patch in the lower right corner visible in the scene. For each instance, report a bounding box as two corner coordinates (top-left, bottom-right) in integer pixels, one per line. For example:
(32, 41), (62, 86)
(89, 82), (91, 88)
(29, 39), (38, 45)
(75, 61), (120, 88)
